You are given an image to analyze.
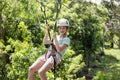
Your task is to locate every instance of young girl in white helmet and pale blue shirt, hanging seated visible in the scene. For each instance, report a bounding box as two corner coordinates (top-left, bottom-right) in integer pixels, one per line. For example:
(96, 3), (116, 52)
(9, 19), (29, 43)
(28, 19), (70, 80)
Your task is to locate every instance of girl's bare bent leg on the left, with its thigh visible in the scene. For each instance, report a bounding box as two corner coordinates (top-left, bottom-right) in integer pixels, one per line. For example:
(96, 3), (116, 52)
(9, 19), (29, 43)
(28, 57), (45, 80)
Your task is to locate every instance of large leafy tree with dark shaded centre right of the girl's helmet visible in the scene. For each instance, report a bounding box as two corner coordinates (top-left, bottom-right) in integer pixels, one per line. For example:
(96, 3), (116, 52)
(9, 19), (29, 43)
(56, 1), (108, 77)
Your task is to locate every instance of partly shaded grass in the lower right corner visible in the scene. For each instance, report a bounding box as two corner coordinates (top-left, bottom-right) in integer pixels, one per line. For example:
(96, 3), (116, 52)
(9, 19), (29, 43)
(91, 49), (120, 80)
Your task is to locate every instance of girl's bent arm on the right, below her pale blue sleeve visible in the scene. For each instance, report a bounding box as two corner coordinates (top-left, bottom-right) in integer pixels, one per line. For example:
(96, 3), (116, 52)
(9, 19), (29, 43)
(53, 33), (67, 53)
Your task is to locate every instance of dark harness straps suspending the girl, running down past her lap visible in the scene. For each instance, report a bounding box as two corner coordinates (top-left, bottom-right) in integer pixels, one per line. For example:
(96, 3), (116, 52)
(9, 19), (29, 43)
(41, 0), (62, 80)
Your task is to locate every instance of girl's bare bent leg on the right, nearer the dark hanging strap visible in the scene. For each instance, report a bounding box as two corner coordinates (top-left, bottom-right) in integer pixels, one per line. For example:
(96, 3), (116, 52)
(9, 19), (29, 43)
(38, 57), (54, 80)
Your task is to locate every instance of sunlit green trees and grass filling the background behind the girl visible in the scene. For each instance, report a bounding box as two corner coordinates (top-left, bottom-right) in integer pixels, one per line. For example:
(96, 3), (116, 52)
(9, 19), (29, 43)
(0, 0), (120, 80)
